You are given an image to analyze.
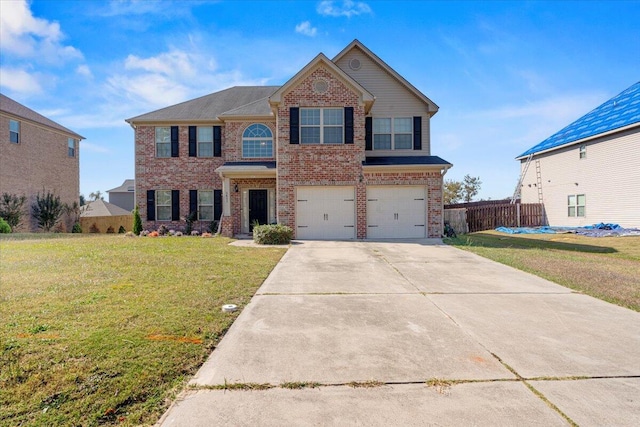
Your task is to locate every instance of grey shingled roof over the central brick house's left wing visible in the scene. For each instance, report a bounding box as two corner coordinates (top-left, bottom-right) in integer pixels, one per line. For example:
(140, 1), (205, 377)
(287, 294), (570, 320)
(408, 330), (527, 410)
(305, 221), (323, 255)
(126, 86), (279, 124)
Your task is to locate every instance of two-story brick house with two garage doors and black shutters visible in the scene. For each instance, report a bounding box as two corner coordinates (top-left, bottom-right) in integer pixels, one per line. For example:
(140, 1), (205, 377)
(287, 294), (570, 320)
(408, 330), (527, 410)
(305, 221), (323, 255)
(127, 40), (452, 239)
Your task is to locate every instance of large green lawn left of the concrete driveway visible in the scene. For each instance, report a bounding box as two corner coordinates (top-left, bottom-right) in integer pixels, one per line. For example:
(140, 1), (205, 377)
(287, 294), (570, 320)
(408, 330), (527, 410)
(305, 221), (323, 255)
(0, 235), (285, 426)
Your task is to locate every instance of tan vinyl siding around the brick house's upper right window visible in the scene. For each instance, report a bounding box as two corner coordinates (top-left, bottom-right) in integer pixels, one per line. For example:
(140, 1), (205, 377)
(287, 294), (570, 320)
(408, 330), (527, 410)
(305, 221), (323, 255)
(336, 49), (431, 156)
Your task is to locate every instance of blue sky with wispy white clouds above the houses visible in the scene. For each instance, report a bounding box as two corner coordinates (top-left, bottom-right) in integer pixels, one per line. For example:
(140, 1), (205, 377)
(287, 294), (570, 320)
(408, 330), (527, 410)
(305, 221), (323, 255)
(0, 0), (640, 199)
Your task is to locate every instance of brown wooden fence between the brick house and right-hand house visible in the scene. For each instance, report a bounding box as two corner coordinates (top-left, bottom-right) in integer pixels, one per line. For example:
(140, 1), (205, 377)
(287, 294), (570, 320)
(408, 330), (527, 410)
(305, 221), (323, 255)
(444, 203), (546, 233)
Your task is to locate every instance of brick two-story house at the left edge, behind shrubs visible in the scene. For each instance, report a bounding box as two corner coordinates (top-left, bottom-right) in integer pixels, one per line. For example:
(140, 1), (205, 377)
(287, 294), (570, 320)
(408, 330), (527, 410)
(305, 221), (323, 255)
(0, 94), (84, 231)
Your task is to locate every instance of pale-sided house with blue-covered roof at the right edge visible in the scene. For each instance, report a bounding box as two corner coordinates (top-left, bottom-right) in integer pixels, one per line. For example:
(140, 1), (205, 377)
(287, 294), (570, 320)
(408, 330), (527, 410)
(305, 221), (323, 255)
(516, 82), (640, 227)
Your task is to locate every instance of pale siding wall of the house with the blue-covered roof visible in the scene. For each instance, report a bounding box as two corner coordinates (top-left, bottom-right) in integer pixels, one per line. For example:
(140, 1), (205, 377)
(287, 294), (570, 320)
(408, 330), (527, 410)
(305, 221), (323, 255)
(521, 126), (640, 228)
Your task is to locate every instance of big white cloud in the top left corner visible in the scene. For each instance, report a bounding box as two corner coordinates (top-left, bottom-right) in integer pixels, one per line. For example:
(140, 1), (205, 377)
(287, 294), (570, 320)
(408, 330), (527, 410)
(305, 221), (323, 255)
(0, 0), (82, 63)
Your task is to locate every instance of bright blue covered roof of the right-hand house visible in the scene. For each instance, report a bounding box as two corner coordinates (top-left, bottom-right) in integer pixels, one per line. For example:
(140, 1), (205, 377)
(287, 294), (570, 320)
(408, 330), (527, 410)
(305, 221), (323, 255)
(516, 82), (640, 159)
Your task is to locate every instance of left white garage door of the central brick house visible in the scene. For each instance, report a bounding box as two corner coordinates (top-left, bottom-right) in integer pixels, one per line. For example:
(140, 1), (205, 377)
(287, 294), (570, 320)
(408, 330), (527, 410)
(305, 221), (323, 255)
(296, 187), (356, 239)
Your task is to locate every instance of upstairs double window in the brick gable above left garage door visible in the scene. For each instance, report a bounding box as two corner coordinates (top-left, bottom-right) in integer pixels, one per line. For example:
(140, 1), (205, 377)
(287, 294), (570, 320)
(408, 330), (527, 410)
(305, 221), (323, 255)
(300, 108), (344, 144)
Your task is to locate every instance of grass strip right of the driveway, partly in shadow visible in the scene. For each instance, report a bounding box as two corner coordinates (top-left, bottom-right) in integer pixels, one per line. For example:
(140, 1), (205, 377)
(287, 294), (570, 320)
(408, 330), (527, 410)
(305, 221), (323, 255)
(445, 231), (640, 311)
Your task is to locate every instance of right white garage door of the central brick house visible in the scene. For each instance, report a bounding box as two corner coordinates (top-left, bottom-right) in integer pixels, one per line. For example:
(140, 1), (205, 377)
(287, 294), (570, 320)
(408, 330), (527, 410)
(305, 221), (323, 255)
(367, 186), (427, 239)
